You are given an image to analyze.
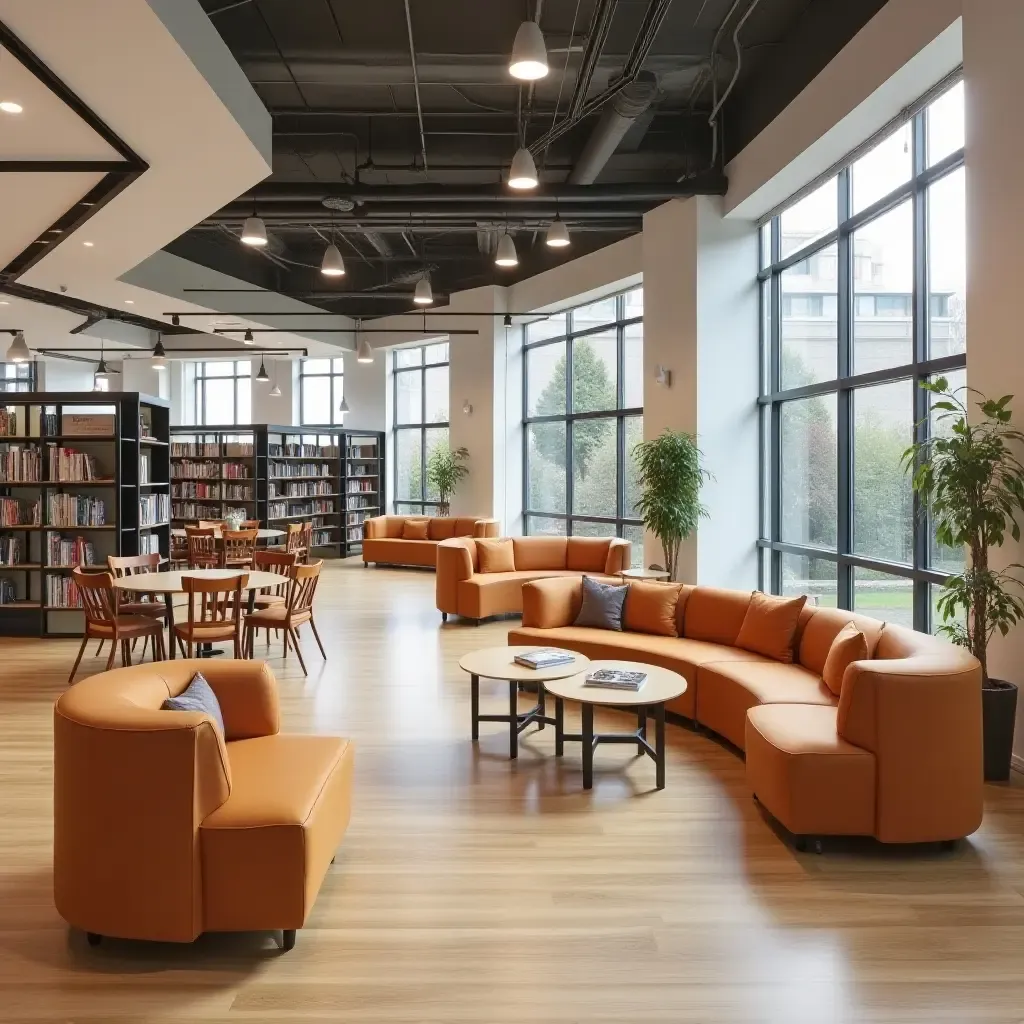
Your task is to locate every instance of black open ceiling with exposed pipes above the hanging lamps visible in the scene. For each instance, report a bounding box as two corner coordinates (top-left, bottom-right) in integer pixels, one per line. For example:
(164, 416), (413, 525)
(170, 0), (885, 315)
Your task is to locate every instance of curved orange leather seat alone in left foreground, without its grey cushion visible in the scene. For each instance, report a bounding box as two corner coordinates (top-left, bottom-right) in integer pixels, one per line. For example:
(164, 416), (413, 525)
(53, 659), (353, 949)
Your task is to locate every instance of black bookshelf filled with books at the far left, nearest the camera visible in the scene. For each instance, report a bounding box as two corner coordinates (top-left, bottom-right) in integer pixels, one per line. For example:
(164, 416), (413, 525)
(0, 391), (170, 636)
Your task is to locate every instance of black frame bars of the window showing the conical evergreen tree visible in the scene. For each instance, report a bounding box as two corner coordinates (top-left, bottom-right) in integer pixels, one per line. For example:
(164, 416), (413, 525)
(522, 285), (643, 537)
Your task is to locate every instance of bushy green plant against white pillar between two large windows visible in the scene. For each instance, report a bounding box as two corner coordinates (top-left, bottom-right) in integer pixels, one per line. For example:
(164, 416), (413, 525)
(633, 429), (711, 580)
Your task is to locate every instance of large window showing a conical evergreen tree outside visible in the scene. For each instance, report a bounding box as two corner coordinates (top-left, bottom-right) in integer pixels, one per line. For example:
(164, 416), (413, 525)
(523, 288), (643, 564)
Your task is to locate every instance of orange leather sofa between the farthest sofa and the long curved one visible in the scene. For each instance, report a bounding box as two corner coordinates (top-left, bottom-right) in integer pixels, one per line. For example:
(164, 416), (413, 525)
(436, 537), (630, 623)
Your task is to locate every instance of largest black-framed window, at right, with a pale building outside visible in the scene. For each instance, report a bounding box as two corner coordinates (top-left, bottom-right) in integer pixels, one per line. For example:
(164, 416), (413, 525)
(758, 83), (967, 630)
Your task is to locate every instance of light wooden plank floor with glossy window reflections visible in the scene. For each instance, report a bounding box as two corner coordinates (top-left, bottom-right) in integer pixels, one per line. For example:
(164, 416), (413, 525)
(0, 562), (1024, 1024)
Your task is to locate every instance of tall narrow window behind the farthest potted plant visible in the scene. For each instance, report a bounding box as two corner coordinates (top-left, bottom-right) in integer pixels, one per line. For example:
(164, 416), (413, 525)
(392, 342), (449, 515)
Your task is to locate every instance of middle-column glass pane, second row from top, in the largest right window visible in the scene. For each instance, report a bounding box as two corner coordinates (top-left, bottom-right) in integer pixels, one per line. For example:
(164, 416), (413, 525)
(853, 200), (913, 374)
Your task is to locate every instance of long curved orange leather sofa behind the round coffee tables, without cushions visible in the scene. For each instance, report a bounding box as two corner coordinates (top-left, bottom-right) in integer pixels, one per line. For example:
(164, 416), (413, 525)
(508, 580), (983, 843)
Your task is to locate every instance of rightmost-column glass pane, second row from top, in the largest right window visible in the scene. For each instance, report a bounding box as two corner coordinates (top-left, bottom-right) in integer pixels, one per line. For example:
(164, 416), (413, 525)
(928, 167), (967, 359)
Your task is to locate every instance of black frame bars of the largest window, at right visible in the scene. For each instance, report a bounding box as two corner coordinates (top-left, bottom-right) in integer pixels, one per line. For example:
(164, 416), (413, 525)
(757, 73), (967, 632)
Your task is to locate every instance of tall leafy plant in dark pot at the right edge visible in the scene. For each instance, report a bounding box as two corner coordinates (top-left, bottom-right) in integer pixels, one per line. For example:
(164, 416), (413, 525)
(903, 377), (1024, 781)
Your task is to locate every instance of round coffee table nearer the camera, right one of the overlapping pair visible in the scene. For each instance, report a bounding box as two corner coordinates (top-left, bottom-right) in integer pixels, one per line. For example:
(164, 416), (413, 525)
(546, 662), (686, 790)
